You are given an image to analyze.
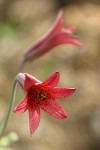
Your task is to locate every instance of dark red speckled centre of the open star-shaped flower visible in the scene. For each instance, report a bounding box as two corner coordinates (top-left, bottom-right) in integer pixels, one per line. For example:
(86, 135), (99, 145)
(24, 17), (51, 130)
(28, 85), (47, 103)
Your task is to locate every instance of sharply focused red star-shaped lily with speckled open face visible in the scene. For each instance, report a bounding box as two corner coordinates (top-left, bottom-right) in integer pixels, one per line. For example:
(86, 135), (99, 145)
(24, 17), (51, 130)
(14, 72), (76, 135)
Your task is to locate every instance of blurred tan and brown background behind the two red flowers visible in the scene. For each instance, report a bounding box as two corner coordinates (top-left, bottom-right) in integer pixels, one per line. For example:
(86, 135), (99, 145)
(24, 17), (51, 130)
(0, 0), (100, 150)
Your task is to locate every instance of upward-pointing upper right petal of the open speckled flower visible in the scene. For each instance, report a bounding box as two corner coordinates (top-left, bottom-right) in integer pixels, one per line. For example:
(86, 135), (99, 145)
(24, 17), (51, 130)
(41, 72), (60, 87)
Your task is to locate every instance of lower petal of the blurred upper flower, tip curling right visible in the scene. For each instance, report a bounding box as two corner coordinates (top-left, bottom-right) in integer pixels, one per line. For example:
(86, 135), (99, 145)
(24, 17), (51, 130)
(26, 31), (80, 59)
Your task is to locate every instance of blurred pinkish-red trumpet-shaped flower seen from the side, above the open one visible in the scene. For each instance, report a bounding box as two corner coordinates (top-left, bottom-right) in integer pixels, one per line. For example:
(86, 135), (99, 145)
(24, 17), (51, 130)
(24, 11), (80, 61)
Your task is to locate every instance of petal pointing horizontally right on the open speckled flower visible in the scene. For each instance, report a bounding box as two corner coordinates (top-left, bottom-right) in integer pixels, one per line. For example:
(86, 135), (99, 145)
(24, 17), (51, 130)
(52, 87), (76, 99)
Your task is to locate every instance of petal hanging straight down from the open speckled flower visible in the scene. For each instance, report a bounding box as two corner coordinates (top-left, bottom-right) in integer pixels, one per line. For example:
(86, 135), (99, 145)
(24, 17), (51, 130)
(28, 105), (40, 135)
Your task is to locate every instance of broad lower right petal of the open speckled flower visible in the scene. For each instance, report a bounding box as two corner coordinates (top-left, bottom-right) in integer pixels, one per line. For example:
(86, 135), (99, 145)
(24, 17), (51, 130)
(40, 99), (67, 120)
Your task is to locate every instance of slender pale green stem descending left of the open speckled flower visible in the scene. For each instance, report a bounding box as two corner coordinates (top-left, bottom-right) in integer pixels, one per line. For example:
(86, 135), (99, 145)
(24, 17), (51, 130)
(0, 79), (17, 138)
